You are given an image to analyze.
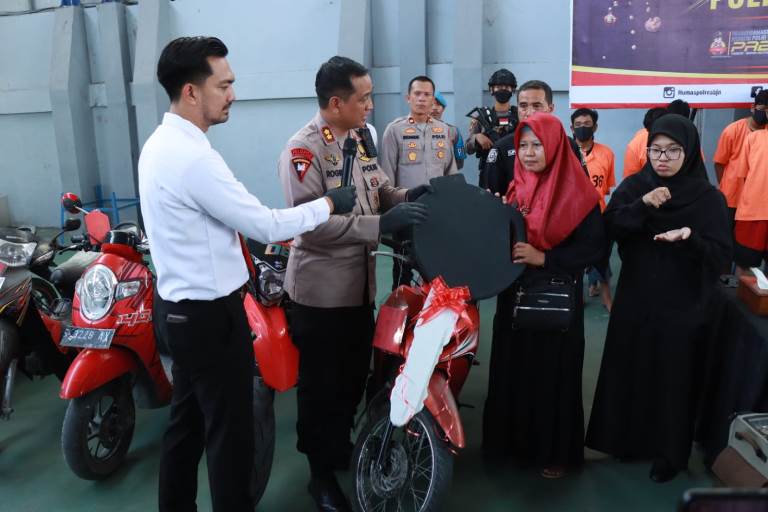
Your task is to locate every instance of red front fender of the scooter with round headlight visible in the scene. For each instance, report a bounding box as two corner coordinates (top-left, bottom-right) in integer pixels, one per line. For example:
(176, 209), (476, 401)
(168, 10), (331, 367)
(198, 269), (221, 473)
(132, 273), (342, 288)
(59, 348), (138, 400)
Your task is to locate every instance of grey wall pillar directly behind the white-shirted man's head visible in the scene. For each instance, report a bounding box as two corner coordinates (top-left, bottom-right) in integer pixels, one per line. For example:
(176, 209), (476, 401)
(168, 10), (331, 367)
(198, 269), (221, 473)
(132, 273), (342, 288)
(133, 0), (171, 151)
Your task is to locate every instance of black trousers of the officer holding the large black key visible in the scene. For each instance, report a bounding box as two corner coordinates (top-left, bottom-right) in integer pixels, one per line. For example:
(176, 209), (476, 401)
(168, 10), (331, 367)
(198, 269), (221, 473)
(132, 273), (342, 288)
(288, 304), (374, 471)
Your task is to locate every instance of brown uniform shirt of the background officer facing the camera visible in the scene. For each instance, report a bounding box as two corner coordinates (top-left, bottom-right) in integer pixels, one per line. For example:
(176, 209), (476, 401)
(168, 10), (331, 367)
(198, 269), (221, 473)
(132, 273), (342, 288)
(379, 116), (458, 188)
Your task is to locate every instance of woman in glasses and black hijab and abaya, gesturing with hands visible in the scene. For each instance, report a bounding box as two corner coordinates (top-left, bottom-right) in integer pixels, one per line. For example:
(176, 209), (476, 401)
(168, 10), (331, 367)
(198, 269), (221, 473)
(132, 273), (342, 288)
(587, 114), (731, 482)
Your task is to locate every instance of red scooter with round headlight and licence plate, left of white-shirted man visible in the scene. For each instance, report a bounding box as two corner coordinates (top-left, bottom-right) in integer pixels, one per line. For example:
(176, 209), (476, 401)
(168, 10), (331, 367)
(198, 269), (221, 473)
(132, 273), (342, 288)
(59, 195), (171, 480)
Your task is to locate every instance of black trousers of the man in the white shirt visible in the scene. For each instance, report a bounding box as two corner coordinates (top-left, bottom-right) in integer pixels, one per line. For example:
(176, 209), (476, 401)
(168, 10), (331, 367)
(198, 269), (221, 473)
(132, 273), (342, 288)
(154, 290), (255, 512)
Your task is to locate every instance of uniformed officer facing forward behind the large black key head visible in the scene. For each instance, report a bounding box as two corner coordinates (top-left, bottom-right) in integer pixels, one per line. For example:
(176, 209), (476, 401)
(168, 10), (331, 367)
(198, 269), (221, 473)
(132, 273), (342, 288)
(380, 75), (458, 289)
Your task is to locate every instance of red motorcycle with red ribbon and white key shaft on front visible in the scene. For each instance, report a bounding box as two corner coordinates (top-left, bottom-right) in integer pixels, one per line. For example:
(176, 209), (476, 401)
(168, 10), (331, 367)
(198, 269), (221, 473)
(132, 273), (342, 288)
(352, 240), (480, 512)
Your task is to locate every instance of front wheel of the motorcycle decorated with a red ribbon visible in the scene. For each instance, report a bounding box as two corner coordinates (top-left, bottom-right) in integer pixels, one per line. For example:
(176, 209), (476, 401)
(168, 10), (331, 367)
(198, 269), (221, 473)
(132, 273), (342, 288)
(352, 404), (453, 512)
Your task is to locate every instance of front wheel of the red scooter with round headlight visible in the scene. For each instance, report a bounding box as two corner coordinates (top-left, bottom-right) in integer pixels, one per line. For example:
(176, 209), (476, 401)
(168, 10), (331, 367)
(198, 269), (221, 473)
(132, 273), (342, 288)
(61, 376), (136, 480)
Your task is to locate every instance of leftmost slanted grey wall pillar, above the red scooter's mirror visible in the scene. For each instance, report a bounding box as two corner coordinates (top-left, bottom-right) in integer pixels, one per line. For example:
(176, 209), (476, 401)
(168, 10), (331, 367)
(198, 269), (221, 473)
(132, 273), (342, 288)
(50, 6), (99, 201)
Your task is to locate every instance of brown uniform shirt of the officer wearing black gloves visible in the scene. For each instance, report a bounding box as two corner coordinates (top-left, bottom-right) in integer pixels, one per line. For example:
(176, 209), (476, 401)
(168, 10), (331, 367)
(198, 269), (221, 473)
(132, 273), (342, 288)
(278, 112), (407, 308)
